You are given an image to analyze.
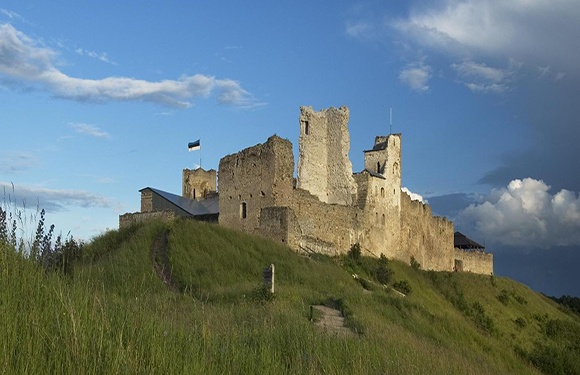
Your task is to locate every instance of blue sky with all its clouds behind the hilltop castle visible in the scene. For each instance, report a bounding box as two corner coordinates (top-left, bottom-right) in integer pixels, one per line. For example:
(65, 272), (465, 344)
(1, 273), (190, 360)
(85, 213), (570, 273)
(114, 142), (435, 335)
(0, 0), (580, 296)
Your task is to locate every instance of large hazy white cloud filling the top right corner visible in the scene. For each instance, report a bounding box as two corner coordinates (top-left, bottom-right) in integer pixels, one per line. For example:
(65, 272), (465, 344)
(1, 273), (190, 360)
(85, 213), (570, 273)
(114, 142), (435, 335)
(392, 0), (580, 72)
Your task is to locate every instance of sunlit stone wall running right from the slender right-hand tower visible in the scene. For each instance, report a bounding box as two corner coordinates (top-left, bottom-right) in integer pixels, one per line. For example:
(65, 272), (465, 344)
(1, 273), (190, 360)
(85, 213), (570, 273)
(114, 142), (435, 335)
(402, 193), (454, 271)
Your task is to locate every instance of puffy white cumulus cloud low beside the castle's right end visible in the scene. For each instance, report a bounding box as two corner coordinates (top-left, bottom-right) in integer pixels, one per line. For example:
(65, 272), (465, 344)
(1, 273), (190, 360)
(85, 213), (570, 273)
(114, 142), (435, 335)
(457, 178), (580, 247)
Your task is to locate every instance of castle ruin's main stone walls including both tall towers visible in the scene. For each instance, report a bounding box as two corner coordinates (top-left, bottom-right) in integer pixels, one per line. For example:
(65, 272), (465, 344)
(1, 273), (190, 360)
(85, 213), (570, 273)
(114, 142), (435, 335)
(218, 106), (493, 274)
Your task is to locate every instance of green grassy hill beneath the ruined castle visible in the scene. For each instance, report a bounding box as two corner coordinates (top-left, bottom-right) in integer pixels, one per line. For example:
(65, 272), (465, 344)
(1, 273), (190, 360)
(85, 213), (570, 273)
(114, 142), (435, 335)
(0, 221), (580, 374)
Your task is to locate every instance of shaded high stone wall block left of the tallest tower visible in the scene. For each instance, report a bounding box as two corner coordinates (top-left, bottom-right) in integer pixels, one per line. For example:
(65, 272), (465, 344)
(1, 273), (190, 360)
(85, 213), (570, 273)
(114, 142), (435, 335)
(219, 136), (294, 233)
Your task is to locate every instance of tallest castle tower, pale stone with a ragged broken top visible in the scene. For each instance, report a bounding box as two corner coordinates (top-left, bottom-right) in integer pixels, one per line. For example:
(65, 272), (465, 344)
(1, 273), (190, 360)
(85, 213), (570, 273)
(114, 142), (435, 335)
(296, 106), (356, 205)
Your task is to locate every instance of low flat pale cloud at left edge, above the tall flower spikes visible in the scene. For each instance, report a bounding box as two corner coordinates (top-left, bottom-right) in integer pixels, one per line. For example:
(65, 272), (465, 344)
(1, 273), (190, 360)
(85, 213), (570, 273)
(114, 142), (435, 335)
(0, 181), (116, 212)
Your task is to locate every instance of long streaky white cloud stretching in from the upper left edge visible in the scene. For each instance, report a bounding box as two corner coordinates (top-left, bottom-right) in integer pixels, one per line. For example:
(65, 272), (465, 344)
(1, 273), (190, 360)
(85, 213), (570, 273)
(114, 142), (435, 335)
(0, 24), (265, 108)
